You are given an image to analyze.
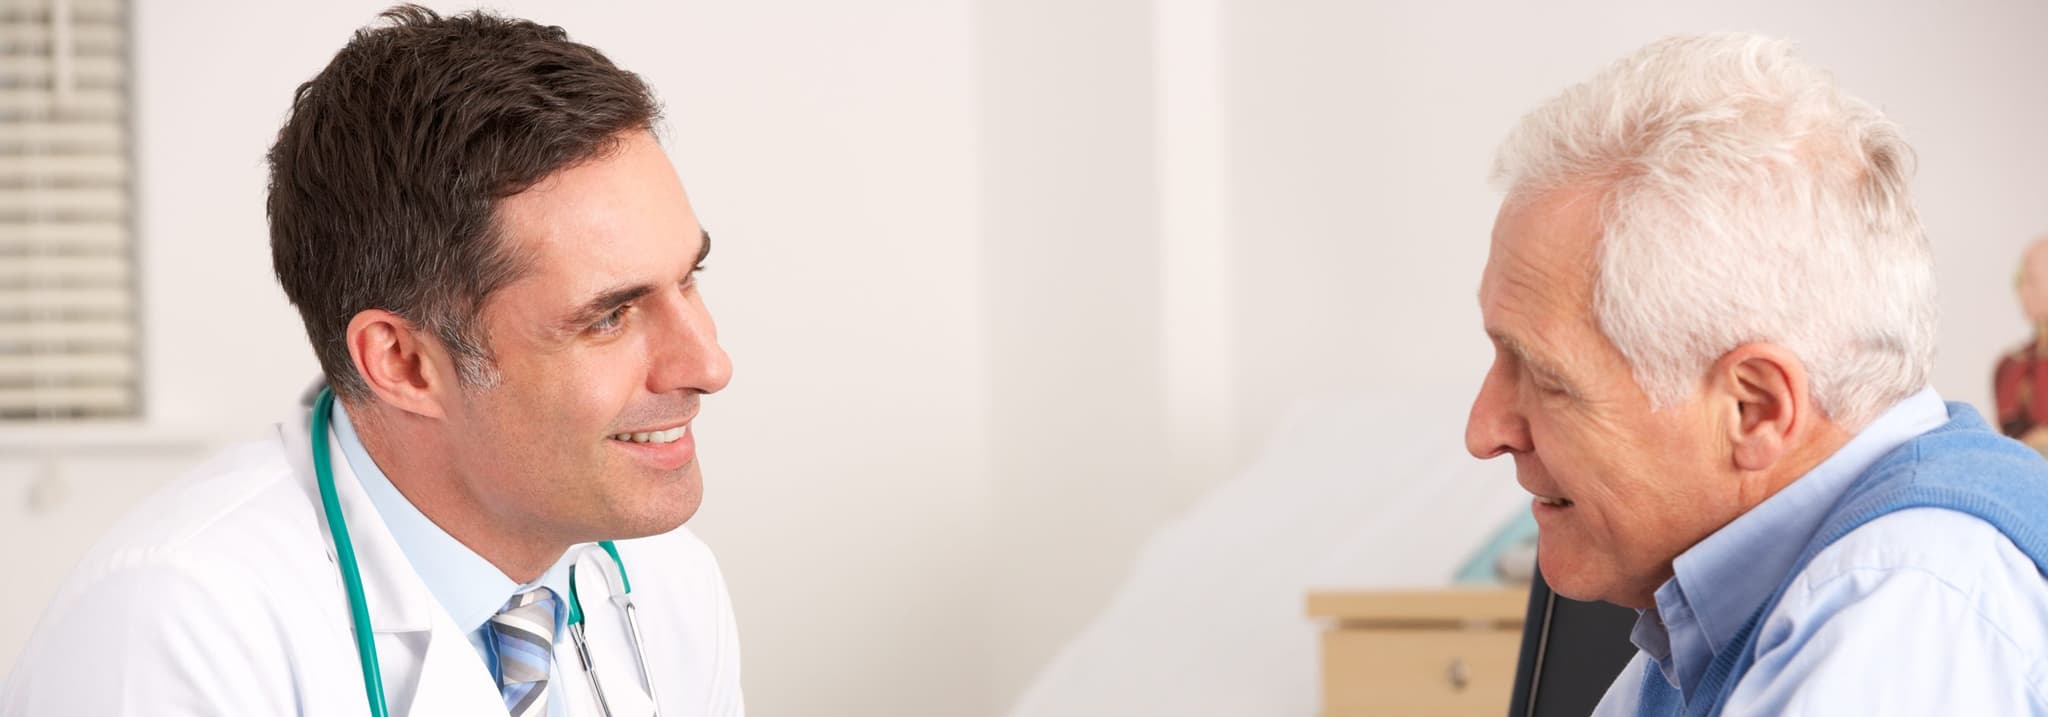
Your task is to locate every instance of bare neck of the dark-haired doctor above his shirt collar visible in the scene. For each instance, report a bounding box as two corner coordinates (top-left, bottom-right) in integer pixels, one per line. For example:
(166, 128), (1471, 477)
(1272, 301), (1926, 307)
(346, 402), (569, 584)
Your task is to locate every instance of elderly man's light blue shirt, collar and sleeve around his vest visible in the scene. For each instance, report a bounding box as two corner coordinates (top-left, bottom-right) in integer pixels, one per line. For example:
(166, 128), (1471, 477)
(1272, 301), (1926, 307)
(1593, 389), (2048, 717)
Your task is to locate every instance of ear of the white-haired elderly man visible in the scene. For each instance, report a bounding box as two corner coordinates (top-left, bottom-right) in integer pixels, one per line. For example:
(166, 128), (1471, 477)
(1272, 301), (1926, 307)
(1710, 344), (1821, 471)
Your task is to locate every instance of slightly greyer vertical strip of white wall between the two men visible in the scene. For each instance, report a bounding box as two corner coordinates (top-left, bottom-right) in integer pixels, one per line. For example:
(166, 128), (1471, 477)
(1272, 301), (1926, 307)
(979, 0), (1167, 701)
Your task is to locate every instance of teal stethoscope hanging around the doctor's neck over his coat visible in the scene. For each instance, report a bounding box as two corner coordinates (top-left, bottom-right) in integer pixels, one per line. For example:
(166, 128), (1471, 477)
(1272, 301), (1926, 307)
(311, 387), (662, 717)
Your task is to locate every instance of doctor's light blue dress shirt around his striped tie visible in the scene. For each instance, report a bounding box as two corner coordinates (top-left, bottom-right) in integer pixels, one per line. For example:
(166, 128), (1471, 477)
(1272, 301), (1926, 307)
(332, 402), (573, 717)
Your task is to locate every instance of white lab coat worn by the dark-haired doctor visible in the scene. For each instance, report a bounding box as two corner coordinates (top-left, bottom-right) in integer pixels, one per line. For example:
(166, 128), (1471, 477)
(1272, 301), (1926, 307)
(0, 401), (745, 717)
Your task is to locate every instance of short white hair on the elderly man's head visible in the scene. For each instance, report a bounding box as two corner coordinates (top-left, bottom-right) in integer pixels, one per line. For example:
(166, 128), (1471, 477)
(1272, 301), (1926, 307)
(1493, 35), (1937, 430)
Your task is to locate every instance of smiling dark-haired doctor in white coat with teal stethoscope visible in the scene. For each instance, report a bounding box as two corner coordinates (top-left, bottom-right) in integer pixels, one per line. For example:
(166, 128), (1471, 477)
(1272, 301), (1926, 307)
(0, 6), (743, 717)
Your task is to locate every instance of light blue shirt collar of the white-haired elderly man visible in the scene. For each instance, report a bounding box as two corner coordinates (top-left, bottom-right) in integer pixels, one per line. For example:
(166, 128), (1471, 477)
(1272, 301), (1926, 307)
(1634, 387), (1948, 697)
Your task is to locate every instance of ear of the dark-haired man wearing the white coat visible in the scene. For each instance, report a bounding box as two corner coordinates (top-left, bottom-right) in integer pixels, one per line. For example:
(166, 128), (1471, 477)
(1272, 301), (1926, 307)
(346, 309), (457, 418)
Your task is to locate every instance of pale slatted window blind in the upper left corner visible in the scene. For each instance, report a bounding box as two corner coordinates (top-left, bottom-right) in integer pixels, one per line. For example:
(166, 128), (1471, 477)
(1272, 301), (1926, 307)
(0, 0), (139, 422)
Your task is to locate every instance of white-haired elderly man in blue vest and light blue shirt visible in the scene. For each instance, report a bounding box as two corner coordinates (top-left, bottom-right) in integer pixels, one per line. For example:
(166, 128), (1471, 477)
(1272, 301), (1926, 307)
(1466, 35), (2048, 715)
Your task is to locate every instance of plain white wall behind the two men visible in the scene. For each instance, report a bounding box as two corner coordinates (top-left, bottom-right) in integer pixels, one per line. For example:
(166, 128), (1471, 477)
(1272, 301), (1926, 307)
(0, 0), (2048, 715)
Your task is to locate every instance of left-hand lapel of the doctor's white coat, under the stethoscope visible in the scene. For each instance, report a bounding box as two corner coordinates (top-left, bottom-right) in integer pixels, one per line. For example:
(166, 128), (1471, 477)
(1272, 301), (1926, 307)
(281, 401), (504, 715)
